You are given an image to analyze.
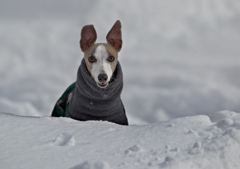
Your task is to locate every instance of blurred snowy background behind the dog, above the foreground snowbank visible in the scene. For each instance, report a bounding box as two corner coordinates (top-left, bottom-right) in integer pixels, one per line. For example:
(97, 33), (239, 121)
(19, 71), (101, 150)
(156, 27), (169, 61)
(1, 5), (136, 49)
(0, 0), (240, 124)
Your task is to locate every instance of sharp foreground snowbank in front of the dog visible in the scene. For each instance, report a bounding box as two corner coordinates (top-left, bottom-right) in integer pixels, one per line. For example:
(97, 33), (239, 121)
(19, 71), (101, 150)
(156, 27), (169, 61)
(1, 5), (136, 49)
(0, 111), (240, 169)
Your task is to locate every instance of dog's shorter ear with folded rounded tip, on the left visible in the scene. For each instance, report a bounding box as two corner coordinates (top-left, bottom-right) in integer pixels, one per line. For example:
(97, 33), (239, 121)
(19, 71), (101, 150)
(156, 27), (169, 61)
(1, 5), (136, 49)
(79, 25), (97, 52)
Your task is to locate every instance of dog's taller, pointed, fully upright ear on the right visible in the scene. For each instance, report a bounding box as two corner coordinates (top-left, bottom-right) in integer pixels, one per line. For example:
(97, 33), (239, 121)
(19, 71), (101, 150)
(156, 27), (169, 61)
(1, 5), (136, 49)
(106, 20), (122, 52)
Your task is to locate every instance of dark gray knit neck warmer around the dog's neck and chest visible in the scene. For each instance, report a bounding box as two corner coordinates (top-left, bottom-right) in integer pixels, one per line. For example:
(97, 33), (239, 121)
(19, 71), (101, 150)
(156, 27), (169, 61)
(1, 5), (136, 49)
(68, 59), (128, 125)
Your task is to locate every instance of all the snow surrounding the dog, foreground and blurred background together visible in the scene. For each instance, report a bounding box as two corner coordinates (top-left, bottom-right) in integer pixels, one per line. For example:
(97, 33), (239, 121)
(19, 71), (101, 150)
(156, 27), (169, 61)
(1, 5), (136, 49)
(0, 0), (240, 169)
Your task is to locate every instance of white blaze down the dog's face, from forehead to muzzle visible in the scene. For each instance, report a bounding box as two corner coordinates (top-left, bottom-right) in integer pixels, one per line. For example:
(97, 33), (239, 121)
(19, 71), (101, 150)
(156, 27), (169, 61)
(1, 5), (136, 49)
(91, 45), (113, 82)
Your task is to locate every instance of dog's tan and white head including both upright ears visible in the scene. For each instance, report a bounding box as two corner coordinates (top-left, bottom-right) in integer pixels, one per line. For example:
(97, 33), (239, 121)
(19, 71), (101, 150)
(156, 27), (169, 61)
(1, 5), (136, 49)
(79, 20), (122, 88)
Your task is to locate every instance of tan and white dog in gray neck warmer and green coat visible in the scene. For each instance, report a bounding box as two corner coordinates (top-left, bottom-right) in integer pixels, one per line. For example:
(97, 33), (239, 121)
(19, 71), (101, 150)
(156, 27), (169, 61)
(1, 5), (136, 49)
(52, 20), (128, 125)
